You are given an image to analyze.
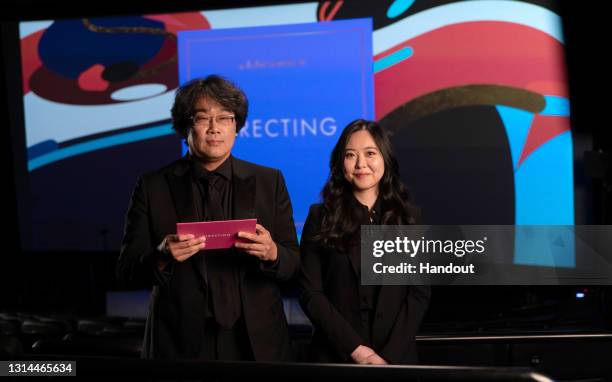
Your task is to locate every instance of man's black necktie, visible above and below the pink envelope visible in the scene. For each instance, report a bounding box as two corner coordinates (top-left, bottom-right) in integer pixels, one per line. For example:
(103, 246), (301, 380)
(205, 173), (241, 329)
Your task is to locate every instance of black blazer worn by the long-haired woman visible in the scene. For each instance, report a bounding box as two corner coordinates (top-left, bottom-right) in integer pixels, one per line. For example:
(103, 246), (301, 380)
(299, 204), (431, 364)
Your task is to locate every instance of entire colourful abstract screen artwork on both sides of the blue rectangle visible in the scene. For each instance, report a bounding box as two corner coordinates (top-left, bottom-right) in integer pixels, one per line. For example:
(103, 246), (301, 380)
(21, 0), (574, 266)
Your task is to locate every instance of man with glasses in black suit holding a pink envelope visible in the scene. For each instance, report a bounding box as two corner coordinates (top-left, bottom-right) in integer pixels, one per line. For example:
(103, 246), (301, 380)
(117, 76), (299, 361)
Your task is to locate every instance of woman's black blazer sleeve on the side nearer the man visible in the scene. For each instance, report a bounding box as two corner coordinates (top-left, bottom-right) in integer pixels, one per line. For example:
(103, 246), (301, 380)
(299, 206), (363, 360)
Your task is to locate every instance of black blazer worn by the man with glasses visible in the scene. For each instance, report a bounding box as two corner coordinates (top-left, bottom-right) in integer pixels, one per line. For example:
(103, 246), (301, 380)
(117, 157), (299, 361)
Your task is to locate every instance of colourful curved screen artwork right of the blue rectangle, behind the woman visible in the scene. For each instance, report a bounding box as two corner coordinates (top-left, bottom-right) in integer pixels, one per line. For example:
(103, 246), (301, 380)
(326, 1), (575, 266)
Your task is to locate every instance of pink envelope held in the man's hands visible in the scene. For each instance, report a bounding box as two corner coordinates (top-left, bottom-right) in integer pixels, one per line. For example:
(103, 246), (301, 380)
(176, 219), (257, 250)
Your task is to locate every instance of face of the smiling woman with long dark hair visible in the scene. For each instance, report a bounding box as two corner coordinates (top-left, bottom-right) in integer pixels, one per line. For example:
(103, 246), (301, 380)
(344, 130), (385, 192)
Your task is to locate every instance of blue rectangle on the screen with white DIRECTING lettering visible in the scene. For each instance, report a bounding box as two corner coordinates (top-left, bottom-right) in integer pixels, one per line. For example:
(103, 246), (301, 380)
(178, 19), (374, 235)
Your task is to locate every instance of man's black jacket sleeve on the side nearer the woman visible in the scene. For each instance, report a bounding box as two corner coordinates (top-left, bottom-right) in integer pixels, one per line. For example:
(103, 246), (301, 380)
(260, 171), (300, 281)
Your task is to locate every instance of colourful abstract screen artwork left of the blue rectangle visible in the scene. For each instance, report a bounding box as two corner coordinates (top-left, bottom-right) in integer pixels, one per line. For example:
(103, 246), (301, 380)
(21, 13), (210, 170)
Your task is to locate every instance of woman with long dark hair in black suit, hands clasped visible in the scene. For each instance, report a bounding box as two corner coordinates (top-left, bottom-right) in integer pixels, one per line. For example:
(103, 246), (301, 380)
(299, 120), (430, 364)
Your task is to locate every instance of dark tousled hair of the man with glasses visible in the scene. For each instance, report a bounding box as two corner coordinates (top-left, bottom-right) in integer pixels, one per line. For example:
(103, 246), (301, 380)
(172, 75), (249, 138)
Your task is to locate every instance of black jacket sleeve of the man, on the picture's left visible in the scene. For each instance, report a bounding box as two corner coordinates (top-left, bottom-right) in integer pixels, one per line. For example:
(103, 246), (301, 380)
(116, 177), (172, 287)
